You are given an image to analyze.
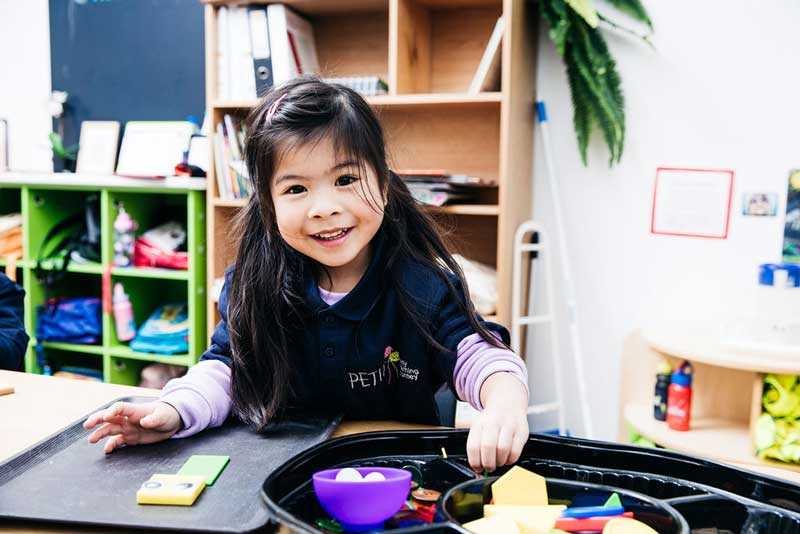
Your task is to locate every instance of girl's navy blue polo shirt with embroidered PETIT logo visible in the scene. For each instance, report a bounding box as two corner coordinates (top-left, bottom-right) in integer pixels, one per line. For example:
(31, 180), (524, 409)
(201, 237), (509, 424)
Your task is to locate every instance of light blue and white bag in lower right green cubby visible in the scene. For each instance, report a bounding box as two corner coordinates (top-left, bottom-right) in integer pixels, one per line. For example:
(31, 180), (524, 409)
(130, 303), (189, 354)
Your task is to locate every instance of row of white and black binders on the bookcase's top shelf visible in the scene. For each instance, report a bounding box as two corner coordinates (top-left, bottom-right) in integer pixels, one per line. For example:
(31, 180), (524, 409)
(217, 4), (319, 100)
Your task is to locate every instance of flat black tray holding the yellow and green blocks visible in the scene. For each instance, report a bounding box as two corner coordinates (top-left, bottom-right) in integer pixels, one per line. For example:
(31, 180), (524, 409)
(0, 397), (338, 533)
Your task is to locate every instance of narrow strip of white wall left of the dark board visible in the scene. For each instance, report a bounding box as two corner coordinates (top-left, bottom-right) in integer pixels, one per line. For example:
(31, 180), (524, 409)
(0, 0), (53, 171)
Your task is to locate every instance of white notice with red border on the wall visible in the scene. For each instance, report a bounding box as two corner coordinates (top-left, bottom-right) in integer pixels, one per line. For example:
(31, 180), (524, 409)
(650, 167), (733, 239)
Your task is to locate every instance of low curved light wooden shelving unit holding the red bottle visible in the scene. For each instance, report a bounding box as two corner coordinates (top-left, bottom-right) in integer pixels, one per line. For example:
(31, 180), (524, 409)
(619, 325), (800, 483)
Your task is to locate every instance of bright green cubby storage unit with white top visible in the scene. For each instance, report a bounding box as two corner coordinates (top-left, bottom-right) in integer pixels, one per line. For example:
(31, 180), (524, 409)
(0, 173), (207, 385)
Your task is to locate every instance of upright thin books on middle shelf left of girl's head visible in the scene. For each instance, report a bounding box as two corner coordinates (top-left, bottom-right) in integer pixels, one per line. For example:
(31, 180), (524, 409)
(214, 114), (253, 200)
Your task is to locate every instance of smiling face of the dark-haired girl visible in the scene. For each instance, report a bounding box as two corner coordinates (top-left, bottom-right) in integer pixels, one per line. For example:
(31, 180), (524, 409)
(270, 138), (386, 292)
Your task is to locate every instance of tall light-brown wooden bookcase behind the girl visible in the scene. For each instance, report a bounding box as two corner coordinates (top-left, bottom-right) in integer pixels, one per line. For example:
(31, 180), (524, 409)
(206, 0), (537, 342)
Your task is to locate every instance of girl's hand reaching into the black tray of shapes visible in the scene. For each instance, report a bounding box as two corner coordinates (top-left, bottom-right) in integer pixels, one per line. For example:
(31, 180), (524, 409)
(467, 373), (528, 473)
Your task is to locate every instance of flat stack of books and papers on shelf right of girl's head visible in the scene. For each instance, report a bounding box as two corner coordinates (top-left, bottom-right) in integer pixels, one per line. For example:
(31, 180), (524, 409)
(395, 170), (497, 206)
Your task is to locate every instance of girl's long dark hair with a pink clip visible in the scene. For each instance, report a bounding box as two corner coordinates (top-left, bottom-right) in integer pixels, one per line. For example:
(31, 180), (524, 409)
(227, 77), (510, 429)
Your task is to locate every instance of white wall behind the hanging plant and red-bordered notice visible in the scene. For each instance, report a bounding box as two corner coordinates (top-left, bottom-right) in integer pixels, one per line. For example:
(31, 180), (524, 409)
(529, 0), (800, 439)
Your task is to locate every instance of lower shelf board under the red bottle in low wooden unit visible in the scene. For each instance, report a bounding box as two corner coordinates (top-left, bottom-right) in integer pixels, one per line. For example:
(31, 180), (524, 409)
(625, 404), (800, 480)
